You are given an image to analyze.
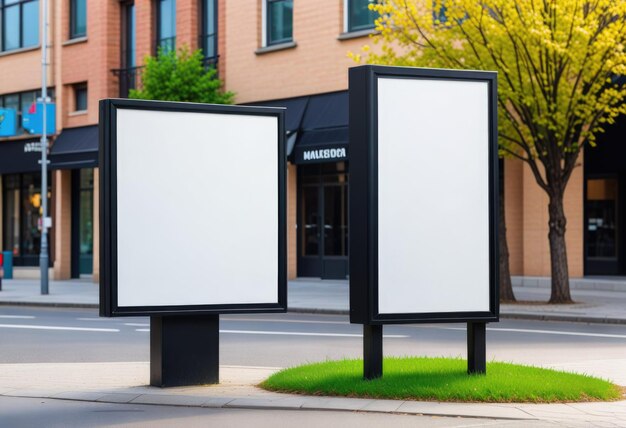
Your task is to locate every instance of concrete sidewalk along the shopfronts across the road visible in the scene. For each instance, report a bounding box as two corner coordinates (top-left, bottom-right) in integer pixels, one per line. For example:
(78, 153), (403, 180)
(0, 278), (626, 324)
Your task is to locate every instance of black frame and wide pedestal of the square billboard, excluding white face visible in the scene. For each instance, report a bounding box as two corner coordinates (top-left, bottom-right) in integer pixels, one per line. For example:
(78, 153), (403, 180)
(99, 99), (287, 387)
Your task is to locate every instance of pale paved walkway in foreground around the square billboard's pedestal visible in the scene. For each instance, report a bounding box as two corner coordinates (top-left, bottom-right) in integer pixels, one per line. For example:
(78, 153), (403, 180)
(0, 362), (626, 427)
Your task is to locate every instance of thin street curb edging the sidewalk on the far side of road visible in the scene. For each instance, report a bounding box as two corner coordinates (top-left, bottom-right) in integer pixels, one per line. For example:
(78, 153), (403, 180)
(0, 301), (626, 325)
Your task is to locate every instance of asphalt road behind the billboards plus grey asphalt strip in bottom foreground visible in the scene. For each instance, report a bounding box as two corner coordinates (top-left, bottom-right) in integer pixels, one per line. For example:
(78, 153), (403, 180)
(0, 306), (626, 428)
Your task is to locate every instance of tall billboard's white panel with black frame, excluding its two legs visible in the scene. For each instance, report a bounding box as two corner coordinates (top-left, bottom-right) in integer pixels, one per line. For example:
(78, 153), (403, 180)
(349, 65), (499, 325)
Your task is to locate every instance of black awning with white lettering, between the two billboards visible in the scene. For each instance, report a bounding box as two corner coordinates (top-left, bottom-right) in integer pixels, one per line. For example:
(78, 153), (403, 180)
(292, 126), (348, 164)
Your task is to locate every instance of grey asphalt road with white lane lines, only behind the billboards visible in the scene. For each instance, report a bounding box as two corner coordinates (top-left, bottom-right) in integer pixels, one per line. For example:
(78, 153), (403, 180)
(0, 306), (626, 376)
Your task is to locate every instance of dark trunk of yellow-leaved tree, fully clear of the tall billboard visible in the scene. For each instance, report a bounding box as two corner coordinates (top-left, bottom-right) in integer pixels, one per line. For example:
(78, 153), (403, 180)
(548, 191), (572, 303)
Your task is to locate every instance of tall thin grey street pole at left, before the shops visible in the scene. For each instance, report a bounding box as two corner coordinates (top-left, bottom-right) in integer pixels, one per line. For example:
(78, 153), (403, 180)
(39, 0), (49, 294)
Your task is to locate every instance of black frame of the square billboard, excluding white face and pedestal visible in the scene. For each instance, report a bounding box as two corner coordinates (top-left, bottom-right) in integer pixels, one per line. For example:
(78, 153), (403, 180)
(99, 99), (287, 317)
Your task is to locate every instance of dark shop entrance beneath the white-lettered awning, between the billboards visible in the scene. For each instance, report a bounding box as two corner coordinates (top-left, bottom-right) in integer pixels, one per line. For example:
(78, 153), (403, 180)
(298, 162), (348, 279)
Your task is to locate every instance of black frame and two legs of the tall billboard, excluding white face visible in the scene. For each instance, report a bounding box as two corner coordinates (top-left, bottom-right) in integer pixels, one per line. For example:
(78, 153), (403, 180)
(349, 65), (500, 378)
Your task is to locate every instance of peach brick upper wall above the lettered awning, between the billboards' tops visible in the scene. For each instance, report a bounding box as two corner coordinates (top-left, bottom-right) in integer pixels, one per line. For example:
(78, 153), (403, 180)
(223, 0), (371, 103)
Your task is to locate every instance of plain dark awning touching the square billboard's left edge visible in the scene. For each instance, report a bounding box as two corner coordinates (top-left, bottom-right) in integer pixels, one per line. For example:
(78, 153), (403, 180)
(50, 125), (98, 169)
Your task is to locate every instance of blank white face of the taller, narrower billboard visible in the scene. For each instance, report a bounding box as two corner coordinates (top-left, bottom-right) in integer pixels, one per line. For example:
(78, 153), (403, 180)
(377, 77), (490, 314)
